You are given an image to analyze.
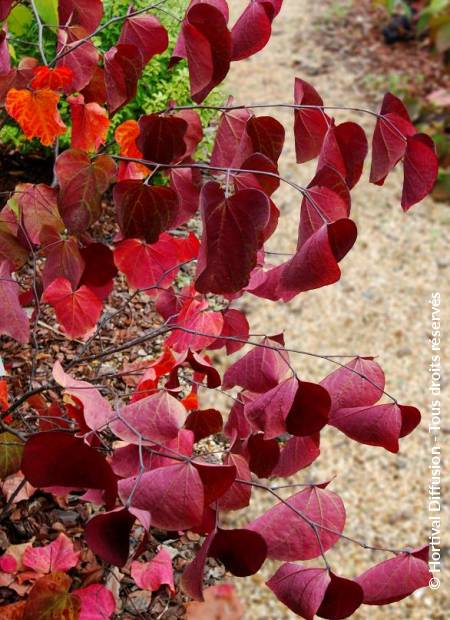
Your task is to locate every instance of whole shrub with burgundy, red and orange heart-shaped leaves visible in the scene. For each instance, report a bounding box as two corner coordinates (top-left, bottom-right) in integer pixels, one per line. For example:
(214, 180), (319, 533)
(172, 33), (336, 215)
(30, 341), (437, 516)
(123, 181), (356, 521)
(0, 0), (439, 620)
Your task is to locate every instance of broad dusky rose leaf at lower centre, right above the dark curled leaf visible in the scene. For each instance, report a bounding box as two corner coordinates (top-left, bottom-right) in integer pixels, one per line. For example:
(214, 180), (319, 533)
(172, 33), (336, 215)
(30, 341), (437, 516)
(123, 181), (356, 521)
(119, 462), (205, 530)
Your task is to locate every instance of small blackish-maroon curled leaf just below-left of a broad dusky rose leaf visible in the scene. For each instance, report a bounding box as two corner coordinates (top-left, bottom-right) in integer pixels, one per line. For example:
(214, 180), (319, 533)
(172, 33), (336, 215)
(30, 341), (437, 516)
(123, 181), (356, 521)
(85, 508), (136, 566)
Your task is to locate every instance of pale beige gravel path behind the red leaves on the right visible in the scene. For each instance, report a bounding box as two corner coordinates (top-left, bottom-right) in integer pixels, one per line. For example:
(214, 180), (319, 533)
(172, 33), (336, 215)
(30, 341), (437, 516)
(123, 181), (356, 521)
(223, 0), (450, 620)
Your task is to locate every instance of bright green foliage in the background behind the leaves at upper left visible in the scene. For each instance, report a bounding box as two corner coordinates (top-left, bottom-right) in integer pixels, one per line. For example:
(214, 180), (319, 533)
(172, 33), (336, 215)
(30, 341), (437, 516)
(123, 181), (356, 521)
(0, 0), (223, 156)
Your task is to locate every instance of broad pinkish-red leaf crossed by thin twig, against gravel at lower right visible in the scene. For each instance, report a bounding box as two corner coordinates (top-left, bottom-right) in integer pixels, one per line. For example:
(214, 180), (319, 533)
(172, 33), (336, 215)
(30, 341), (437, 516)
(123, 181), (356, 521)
(247, 486), (345, 561)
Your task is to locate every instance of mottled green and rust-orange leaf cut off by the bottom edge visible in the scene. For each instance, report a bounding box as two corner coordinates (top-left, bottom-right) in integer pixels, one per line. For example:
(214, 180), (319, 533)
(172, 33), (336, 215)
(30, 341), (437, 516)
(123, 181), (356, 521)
(23, 573), (81, 620)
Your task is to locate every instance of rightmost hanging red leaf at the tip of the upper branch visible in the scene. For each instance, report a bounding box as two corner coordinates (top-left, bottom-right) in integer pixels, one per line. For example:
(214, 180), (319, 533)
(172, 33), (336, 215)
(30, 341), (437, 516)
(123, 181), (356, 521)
(402, 133), (439, 211)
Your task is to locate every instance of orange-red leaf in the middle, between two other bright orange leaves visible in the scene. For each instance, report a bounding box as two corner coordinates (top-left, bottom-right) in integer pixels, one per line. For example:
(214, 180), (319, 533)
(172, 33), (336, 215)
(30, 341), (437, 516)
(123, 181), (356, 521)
(67, 95), (109, 151)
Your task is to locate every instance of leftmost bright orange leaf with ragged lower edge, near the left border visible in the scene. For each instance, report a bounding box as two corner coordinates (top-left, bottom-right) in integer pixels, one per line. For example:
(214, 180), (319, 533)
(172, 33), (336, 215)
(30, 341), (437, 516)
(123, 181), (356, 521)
(6, 88), (67, 146)
